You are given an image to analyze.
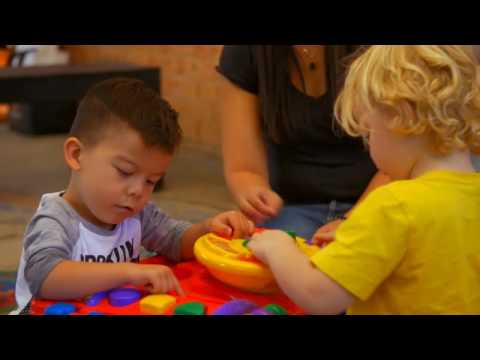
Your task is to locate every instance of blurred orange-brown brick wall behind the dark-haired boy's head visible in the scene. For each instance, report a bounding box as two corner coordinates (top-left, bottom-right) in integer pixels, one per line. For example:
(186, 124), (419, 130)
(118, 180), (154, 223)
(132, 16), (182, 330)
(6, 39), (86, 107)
(66, 45), (222, 152)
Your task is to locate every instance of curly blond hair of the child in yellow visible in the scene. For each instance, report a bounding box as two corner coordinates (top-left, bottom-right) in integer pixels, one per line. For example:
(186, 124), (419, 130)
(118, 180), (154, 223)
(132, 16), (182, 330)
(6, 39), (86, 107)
(335, 45), (480, 154)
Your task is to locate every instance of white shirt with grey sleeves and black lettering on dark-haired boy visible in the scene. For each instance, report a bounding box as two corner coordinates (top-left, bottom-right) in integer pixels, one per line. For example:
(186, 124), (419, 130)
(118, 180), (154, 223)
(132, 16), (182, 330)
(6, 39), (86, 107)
(14, 192), (191, 313)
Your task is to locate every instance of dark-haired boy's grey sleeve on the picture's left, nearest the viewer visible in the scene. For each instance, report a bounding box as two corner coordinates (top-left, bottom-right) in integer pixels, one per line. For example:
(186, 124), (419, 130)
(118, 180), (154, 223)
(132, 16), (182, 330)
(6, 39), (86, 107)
(24, 217), (76, 296)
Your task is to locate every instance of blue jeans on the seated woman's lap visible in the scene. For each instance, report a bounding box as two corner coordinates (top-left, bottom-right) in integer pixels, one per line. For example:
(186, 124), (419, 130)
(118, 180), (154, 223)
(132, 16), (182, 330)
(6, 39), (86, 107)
(260, 201), (353, 240)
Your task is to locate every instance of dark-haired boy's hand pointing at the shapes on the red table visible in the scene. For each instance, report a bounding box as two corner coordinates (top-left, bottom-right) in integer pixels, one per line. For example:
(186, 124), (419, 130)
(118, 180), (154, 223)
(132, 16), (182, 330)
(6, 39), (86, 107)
(124, 263), (185, 295)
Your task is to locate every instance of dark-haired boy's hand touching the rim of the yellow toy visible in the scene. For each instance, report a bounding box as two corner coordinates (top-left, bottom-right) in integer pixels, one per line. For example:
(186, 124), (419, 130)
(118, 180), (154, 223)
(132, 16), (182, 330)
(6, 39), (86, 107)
(207, 211), (255, 239)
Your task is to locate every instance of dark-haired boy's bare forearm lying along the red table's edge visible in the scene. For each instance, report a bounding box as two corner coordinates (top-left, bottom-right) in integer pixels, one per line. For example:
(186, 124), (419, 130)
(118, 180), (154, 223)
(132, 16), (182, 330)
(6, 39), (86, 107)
(39, 261), (135, 300)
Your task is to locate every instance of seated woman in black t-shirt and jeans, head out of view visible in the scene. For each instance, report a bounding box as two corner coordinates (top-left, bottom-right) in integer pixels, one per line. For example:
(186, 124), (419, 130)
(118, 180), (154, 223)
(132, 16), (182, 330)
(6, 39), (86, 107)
(217, 45), (386, 239)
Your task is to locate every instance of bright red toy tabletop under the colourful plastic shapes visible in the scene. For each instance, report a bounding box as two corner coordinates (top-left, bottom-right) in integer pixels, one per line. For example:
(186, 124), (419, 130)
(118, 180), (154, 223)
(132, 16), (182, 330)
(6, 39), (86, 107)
(30, 257), (303, 315)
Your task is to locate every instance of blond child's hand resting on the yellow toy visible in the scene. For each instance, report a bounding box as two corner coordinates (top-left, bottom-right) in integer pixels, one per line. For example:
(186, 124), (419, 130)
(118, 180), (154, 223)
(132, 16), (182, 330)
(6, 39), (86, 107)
(247, 230), (296, 264)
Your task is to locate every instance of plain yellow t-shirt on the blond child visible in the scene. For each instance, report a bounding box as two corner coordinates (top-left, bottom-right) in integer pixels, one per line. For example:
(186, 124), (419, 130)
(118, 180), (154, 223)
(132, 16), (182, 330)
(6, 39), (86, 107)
(312, 171), (480, 314)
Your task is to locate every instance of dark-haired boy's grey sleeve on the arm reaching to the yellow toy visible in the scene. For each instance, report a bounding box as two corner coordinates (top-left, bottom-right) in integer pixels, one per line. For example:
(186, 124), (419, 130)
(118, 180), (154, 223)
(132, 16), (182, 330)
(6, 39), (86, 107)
(140, 202), (192, 262)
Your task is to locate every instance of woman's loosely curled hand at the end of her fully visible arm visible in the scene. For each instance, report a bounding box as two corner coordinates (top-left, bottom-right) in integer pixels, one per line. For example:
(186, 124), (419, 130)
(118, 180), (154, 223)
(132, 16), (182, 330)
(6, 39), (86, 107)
(237, 186), (283, 224)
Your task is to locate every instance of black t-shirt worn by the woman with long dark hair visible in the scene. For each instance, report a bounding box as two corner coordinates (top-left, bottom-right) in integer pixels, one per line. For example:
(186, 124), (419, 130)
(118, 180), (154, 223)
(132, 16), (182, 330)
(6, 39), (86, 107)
(217, 45), (376, 204)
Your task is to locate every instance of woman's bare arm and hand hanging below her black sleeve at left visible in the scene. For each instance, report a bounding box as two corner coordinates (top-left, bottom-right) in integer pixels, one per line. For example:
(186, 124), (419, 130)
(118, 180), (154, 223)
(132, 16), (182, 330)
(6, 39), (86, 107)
(220, 74), (282, 223)
